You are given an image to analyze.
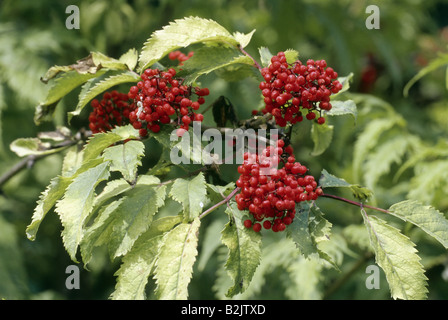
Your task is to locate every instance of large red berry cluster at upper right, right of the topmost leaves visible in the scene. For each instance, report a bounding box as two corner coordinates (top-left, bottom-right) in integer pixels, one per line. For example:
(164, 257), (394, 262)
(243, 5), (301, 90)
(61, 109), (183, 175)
(259, 52), (342, 127)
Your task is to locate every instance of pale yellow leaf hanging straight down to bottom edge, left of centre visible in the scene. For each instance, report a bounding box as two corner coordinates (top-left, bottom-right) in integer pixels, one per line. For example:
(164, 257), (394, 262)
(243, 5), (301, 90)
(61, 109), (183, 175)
(154, 218), (201, 300)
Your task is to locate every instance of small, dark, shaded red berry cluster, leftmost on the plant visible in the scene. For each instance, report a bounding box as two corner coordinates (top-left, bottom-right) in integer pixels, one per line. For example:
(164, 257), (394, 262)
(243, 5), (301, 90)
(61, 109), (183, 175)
(89, 90), (135, 133)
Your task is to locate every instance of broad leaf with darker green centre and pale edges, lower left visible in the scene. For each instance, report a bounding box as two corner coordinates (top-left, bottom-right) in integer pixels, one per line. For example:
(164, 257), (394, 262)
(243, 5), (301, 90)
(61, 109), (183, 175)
(81, 176), (166, 264)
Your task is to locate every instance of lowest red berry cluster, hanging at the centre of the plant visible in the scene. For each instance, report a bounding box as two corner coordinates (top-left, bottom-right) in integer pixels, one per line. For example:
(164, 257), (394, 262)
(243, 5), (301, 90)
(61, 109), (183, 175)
(235, 140), (322, 232)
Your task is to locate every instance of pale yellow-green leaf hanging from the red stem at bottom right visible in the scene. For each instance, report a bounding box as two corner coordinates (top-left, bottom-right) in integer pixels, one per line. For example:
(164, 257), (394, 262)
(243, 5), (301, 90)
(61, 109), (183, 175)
(363, 212), (427, 300)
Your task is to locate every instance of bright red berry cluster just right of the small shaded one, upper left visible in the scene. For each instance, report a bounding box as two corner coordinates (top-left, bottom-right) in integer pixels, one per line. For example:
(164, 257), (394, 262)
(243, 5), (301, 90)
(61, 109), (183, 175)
(128, 68), (209, 137)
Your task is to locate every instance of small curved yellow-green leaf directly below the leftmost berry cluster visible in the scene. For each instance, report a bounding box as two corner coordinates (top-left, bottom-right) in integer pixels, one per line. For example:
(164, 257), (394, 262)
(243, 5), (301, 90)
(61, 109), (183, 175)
(83, 125), (140, 162)
